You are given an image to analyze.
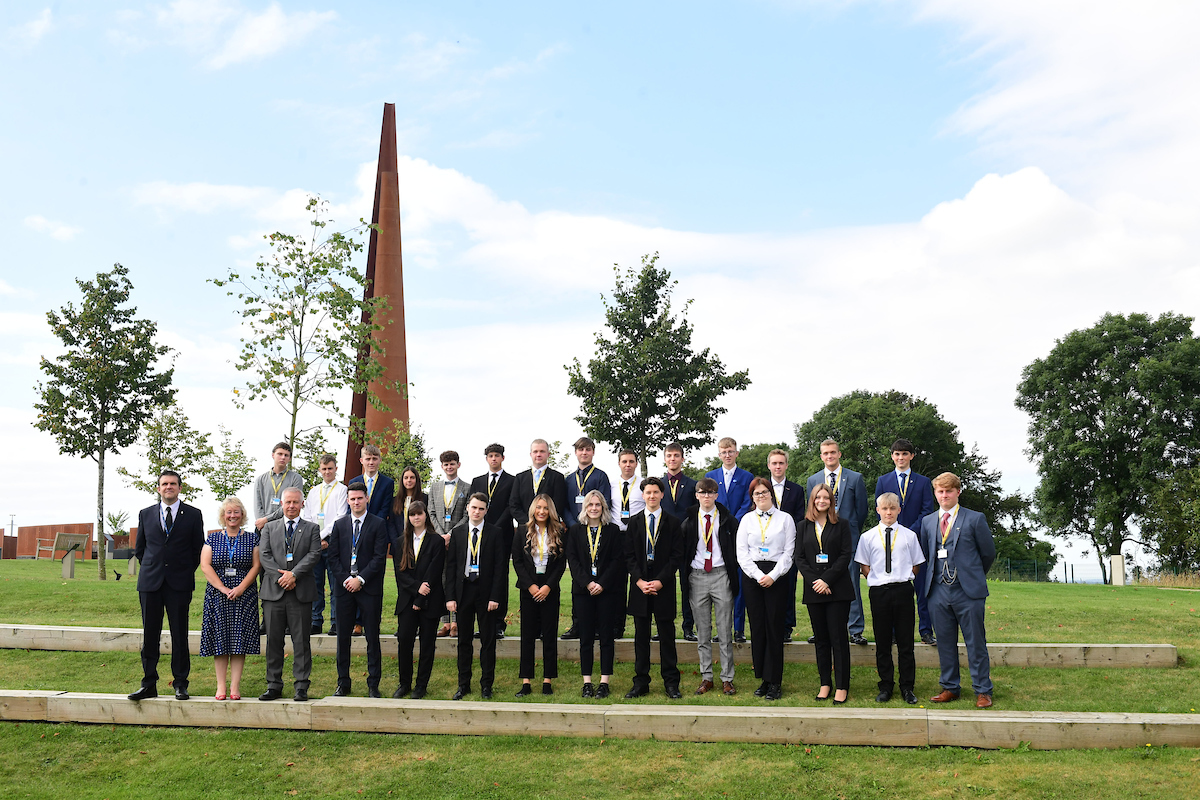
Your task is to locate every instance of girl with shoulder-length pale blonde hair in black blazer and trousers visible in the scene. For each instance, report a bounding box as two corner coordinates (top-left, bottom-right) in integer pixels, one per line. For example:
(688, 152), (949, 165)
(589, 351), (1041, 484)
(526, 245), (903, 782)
(566, 489), (625, 698)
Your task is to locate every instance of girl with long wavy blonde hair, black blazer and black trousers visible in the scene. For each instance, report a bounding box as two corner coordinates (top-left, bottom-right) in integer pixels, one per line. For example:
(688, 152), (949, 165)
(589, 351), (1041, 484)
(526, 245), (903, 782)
(512, 494), (566, 697)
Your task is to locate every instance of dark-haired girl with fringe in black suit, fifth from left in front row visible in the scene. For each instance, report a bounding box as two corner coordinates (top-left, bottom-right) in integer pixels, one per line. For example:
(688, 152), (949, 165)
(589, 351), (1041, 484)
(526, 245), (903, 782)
(388, 497), (446, 700)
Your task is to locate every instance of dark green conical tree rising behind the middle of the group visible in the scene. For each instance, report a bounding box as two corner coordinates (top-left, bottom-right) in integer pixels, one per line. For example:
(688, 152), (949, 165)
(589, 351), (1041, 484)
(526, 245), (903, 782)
(566, 253), (750, 474)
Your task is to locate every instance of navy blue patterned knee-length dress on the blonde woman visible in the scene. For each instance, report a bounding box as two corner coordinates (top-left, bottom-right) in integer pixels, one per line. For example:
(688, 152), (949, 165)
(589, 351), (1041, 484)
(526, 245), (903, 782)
(200, 530), (259, 656)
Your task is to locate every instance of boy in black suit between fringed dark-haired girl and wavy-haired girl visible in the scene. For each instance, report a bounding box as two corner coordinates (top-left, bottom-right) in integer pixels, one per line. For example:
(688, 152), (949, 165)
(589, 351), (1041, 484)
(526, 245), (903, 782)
(444, 493), (512, 700)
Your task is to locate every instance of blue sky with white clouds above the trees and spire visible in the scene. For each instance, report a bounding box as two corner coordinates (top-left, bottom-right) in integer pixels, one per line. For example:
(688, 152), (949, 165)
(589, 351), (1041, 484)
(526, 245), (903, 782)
(0, 0), (1200, 575)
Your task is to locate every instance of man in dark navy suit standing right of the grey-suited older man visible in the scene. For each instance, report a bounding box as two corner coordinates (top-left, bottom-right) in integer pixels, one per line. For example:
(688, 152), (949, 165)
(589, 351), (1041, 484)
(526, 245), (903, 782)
(325, 482), (388, 697)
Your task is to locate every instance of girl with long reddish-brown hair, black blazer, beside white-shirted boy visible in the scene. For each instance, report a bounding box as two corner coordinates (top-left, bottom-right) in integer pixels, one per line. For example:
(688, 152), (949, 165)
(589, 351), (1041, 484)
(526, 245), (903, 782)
(796, 483), (854, 705)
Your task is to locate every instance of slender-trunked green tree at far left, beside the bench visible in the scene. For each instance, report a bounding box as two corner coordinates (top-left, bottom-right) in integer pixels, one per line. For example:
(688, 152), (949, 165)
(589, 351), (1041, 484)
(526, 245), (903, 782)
(34, 264), (175, 581)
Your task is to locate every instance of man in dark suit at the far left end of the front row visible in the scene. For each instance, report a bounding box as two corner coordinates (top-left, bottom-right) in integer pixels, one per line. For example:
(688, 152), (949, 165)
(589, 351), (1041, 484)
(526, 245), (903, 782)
(130, 470), (204, 700)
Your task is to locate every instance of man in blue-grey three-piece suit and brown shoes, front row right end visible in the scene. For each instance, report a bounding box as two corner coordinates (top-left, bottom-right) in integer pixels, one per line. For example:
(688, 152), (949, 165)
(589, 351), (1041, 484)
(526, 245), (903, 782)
(920, 473), (996, 709)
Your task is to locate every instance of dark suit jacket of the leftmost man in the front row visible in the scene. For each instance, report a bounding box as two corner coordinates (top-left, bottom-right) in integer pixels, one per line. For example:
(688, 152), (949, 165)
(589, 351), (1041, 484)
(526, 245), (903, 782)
(134, 503), (204, 591)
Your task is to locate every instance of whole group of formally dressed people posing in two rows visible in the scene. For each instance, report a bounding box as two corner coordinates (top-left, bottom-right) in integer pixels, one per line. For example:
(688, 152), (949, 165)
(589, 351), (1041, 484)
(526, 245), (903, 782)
(130, 437), (995, 708)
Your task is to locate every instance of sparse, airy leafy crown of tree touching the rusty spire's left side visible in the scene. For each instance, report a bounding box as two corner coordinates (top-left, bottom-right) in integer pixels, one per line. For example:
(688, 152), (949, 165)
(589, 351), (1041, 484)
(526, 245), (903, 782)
(210, 197), (390, 449)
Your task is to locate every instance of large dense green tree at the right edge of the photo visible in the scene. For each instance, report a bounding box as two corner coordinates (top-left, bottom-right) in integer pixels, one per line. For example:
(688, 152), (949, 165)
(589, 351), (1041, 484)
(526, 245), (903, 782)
(1016, 313), (1200, 582)
